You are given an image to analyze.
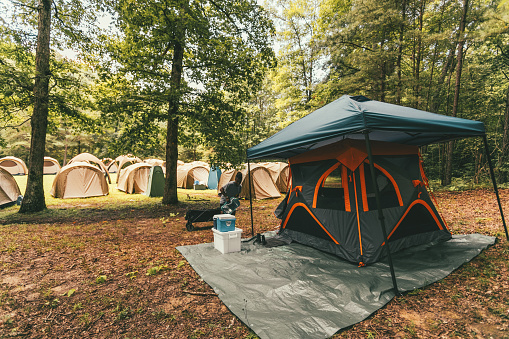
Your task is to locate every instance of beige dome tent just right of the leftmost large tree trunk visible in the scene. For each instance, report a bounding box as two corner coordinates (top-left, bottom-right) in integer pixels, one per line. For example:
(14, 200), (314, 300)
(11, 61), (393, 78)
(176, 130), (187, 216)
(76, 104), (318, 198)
(50, 162), (109, 199)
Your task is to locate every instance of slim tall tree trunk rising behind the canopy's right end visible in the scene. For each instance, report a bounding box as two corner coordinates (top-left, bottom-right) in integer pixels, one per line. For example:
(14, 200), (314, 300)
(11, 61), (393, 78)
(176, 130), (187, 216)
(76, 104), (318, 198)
(444, 0), (468, 185)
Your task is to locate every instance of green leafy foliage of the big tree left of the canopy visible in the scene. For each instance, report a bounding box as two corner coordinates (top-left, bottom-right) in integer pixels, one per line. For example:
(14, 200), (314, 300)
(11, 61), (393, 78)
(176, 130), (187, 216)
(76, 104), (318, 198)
(90, 0), (274, 171)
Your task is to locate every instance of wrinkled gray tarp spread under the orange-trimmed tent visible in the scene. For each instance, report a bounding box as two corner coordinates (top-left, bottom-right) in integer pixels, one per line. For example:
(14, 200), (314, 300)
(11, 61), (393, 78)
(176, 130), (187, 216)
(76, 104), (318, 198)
(177, 233), (495, 339)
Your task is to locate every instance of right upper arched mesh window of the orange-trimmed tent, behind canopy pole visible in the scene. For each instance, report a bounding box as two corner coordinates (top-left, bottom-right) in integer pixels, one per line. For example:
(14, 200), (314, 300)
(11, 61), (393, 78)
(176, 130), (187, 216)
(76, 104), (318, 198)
(361, 163), (400, 211)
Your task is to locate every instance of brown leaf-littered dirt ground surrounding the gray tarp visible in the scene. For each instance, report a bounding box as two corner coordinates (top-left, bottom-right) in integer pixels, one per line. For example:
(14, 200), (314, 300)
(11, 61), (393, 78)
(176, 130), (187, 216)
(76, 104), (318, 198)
(0, 190), (509, 338)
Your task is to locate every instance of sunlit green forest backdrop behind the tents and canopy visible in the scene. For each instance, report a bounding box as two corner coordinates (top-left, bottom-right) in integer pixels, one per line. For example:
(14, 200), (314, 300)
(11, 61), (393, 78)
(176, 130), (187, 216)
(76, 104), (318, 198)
(0, 0), (509, 203)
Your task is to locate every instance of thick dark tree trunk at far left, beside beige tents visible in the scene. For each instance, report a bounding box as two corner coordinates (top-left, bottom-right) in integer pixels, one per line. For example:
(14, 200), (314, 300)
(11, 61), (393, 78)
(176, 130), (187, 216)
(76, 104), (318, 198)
(19, 0), (51, 213)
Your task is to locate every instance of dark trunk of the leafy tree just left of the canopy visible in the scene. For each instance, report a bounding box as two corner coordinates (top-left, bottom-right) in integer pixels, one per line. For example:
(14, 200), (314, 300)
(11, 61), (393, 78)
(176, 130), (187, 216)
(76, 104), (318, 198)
(163, 24), (185, 205)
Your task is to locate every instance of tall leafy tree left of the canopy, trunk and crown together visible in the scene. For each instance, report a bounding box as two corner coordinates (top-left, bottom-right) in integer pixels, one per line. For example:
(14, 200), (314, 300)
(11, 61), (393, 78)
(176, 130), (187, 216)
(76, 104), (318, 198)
(96, 0), (273, 204)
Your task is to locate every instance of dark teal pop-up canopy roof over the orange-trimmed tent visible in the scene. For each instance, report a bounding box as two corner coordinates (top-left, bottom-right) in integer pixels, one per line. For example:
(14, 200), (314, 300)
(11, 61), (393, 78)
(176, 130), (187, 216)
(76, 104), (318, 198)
(247, 95), (485, 159)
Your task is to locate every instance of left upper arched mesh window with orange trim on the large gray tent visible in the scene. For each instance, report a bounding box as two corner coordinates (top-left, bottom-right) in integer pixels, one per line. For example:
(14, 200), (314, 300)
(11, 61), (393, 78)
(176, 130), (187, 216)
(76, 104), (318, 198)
(316, 166), (345, 211)
